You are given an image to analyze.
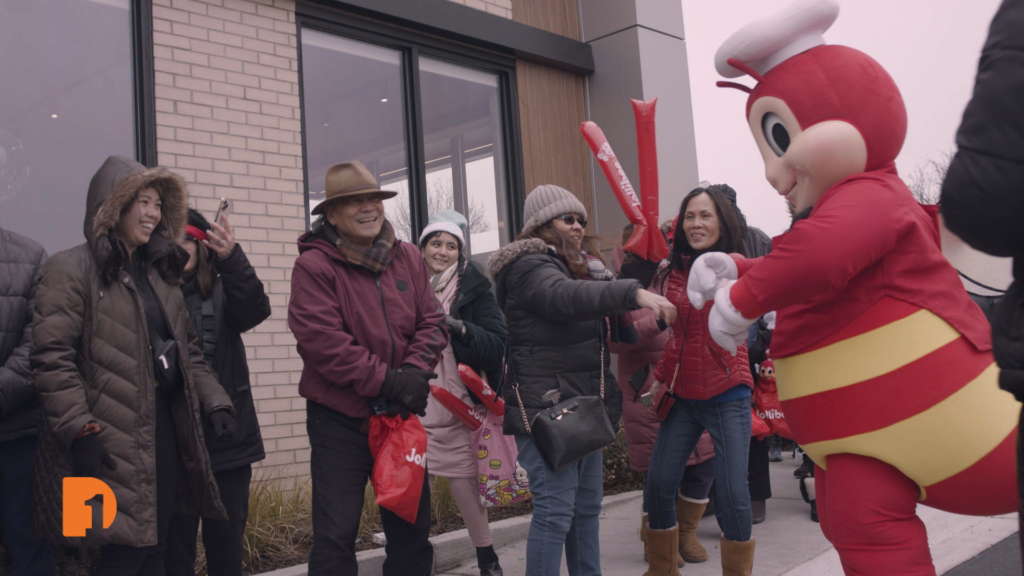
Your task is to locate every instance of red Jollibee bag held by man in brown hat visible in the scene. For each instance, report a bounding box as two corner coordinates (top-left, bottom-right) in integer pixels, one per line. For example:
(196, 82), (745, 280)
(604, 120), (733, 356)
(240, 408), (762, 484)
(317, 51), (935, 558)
(370, 415), (427, 524)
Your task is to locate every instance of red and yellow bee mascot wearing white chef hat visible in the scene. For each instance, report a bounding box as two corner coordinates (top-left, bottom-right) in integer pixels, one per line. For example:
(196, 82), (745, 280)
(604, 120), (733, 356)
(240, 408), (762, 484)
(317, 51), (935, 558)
(688, 0), (1020, 576)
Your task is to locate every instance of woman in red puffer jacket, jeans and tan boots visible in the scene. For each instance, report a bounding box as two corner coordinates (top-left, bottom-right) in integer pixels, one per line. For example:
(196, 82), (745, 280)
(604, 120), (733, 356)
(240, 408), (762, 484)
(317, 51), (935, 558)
(645, 187), (754, 576)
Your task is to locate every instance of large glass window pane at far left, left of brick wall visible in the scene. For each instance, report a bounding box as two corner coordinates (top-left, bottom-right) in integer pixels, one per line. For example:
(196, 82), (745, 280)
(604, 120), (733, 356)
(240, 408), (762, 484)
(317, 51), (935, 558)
(0, 0), (135, 253)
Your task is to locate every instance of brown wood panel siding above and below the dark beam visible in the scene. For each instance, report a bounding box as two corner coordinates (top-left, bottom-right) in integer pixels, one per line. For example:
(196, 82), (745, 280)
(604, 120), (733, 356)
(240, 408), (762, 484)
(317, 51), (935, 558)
(512, 0), (593, 218)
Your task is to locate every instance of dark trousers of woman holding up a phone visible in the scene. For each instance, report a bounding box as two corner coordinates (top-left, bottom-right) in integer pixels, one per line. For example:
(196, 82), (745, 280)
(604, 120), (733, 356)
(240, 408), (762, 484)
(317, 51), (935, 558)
(164, 464), (253, 576)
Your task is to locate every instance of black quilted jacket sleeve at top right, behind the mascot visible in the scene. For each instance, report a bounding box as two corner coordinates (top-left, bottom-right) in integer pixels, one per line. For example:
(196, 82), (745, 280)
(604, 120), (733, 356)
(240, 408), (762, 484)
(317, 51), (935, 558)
(940, 0), (1024, 256)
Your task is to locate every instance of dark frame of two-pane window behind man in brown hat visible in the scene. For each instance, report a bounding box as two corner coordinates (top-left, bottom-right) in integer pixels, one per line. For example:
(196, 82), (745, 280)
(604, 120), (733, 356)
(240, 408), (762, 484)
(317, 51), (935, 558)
(296, 9), (525, 242)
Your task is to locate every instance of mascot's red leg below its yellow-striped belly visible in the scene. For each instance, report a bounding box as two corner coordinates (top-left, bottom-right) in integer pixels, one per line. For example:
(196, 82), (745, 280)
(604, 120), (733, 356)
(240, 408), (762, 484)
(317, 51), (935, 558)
(816, 454), (935, 576)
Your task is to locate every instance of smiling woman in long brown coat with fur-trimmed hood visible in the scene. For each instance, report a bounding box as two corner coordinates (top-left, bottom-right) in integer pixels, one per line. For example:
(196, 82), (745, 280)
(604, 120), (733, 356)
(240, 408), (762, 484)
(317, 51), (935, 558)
(31, 157), (233, 574)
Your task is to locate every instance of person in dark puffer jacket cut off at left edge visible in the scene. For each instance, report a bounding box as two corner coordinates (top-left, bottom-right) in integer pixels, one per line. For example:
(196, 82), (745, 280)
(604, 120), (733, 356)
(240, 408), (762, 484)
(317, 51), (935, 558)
(0, 229), (56, 576)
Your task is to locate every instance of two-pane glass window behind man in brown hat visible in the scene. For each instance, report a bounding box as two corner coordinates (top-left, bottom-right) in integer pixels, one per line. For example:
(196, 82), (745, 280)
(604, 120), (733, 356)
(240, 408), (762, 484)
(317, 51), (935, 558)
(301, 21), (513, 255)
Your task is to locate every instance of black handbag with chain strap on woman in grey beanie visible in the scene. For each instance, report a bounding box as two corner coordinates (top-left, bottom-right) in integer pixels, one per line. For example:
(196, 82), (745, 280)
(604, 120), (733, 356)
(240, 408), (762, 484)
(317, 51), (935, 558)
(508, 341), (615, 470)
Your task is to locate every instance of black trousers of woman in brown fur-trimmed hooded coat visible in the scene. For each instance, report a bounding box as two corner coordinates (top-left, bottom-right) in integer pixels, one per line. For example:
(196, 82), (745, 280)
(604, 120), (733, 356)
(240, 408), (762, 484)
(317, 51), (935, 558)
(95, 390), (179, 576)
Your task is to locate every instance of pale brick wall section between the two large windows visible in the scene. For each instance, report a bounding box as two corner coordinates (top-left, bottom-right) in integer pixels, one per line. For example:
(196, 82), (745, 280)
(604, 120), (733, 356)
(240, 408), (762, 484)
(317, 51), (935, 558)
(153, 0), (309, 478)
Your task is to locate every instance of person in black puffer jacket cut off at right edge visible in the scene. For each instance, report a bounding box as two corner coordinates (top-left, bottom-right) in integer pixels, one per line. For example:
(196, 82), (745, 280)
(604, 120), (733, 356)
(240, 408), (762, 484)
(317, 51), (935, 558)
(939, 0), (1024, 553)
